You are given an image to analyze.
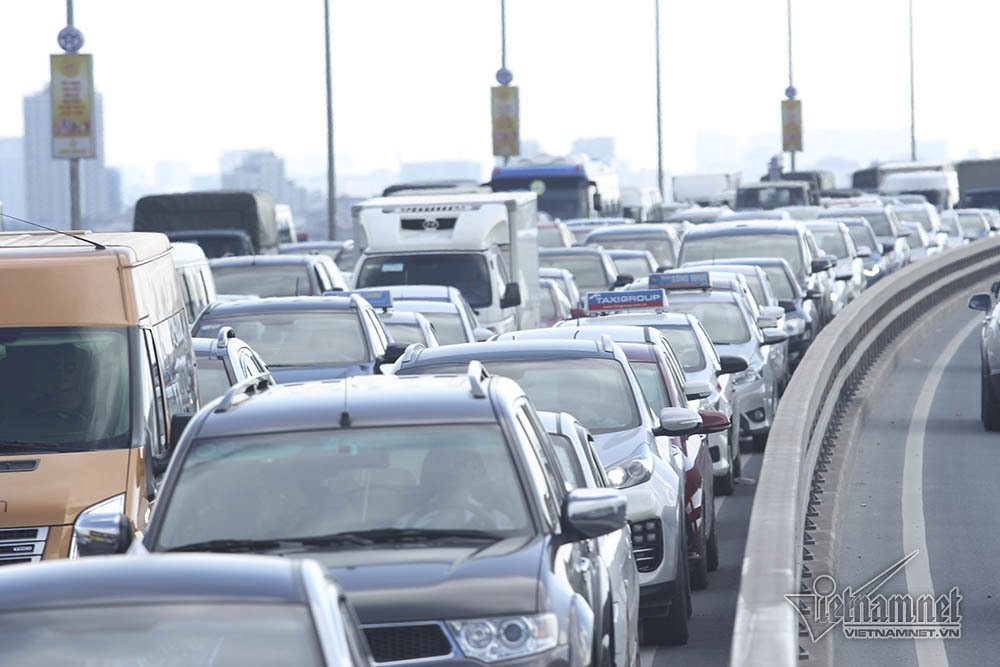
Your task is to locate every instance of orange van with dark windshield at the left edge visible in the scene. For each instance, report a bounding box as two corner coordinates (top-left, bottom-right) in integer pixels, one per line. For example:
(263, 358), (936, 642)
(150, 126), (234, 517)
(0, 232), (198, 565)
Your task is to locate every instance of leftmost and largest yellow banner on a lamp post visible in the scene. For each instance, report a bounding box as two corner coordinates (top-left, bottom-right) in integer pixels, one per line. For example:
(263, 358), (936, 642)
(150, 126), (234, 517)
(49, 53), (97, 158)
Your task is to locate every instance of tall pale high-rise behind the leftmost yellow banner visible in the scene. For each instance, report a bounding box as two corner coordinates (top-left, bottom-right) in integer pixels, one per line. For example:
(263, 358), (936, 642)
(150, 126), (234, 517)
(24, 86), (112, 229)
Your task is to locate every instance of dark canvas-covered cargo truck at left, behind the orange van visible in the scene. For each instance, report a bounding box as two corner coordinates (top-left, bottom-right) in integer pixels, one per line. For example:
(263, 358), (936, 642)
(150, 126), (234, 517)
(133, 190), (278, 258)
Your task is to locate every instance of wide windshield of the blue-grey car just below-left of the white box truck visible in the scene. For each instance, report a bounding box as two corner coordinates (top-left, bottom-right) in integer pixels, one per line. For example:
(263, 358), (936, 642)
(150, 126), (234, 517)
(194, 310), (368, 368)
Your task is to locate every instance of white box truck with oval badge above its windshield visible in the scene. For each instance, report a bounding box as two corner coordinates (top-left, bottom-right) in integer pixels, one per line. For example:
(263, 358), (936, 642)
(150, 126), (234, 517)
(351, 192), (540, 333)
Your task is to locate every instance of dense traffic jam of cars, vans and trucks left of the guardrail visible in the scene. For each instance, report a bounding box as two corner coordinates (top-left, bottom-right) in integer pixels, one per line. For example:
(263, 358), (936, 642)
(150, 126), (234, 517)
(0, 163), (1000, 667)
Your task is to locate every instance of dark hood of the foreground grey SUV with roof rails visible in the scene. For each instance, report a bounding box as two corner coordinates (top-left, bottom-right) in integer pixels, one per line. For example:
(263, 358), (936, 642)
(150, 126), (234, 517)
(306, 535), (548, 624)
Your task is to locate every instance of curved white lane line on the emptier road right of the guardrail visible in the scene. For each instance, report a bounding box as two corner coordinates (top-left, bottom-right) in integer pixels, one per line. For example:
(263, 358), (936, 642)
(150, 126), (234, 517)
(902, 317), (983, 667)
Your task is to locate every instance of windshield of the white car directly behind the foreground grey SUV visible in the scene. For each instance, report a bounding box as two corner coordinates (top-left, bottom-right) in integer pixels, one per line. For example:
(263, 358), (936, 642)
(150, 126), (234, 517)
(416, 359), (641, 433)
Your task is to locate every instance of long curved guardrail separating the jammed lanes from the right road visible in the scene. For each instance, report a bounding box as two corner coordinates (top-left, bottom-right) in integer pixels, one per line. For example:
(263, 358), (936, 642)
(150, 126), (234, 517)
(730, 238), (1000, 667)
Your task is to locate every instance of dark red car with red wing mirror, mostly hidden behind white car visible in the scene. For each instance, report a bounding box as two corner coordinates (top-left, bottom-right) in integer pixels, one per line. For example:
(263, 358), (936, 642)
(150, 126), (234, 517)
(615, 342), (729, 590)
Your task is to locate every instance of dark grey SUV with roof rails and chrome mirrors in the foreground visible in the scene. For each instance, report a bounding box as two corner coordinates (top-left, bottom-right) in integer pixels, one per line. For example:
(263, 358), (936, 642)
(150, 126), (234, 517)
(87, 374), (638, 667)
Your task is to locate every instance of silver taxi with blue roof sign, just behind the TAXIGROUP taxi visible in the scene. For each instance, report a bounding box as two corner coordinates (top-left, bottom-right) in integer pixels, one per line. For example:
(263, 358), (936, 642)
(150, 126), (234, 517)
(632, 271), (788, 447)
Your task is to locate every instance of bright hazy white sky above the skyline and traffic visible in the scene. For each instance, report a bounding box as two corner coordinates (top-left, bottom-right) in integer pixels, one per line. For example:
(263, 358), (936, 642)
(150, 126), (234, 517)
(0, 0), (1000, 180)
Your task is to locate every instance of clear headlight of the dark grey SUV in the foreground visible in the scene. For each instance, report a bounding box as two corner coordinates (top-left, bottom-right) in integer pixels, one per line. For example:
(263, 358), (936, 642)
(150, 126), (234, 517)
(448, 613), (559, 662)
